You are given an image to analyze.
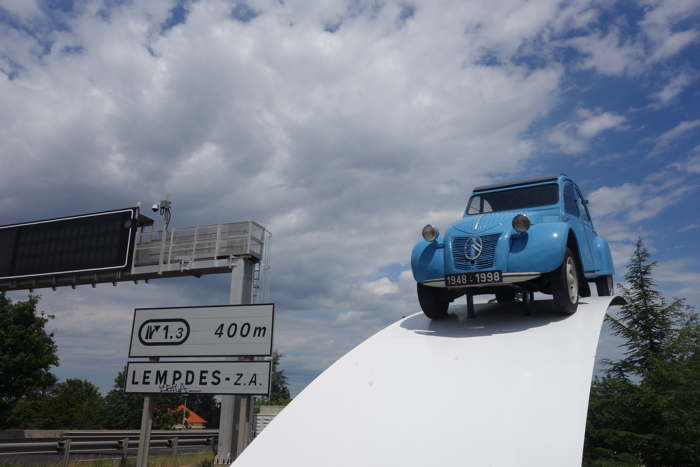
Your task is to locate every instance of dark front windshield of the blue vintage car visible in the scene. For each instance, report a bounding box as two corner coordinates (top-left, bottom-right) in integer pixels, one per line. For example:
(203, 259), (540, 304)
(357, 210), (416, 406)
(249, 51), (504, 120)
(467, 183), (559, 214)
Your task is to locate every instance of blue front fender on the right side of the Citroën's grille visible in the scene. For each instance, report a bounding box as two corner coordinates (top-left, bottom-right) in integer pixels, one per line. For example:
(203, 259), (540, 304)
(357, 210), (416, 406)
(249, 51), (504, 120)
(508, 222), (570, 273)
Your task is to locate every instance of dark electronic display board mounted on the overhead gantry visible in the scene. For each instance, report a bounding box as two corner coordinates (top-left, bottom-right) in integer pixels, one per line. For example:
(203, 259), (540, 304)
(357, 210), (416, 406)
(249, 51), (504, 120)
(0, 208), (138, 279)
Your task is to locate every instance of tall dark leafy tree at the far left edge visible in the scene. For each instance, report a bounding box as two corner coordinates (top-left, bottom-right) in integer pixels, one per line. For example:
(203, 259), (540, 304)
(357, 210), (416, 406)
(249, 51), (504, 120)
(0, 294), (58, 428)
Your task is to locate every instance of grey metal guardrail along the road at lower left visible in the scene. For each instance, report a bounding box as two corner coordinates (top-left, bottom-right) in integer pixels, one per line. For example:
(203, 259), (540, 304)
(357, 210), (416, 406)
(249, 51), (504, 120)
(0, 430), (219, 466)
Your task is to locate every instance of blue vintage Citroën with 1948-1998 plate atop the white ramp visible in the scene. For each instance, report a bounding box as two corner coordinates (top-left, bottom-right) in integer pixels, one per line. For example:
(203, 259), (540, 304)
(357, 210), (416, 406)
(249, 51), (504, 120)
(411, 174), (614, 320)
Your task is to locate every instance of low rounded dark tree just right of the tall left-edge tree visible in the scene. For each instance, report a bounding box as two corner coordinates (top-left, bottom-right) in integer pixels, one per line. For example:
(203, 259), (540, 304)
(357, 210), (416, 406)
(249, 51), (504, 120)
(44, 379), (103, 430)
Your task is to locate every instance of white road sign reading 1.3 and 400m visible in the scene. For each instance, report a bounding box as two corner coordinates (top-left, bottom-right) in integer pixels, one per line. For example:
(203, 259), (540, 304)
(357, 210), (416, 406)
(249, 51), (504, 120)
(129, 304), (275, 357)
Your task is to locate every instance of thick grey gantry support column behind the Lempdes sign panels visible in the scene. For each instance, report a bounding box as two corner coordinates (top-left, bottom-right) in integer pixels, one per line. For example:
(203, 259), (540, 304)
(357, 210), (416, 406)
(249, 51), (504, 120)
(214, 258), (254, 465)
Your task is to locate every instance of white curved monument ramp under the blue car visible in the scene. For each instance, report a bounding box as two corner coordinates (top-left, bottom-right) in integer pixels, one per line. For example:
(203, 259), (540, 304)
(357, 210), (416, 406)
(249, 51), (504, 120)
(233, 297), (624, 467)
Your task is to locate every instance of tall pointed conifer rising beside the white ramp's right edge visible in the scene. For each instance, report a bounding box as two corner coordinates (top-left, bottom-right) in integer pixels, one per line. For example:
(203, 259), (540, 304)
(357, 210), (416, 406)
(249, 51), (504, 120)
(606, 237), (685, 377)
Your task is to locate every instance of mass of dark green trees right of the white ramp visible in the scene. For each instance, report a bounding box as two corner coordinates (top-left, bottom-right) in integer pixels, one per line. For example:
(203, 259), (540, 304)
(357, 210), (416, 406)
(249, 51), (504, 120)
(584, 239), (700, 466)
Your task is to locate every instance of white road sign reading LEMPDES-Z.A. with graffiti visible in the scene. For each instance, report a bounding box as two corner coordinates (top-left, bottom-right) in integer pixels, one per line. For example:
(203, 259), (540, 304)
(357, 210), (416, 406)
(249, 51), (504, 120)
(125, 361), (270, 396)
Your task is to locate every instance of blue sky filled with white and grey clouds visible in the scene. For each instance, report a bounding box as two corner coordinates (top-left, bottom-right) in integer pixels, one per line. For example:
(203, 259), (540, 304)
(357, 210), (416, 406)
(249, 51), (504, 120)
(0, 0), (700, 393)
